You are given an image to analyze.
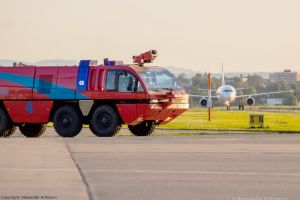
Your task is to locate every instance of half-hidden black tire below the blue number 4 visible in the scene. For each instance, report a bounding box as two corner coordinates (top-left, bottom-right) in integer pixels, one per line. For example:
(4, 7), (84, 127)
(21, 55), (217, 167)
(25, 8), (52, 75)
(19, 123), (47, 137)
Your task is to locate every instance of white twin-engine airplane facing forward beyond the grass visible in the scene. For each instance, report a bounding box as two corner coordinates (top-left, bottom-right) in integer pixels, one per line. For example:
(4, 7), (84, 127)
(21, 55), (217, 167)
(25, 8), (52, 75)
(189, 66), (292, 110)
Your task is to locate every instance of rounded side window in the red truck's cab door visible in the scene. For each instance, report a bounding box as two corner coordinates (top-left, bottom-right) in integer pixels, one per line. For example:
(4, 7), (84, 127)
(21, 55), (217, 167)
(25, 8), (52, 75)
(118, 71), (137, 92)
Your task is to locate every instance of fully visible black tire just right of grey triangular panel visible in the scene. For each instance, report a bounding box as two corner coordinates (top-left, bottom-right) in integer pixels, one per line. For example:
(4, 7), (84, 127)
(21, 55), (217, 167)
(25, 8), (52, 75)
(90, 105), (121, 137)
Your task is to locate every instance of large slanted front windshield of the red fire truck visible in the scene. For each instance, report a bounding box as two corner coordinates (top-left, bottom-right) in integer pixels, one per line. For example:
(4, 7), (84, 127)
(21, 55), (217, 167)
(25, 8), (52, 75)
(138, 68), (182, 91)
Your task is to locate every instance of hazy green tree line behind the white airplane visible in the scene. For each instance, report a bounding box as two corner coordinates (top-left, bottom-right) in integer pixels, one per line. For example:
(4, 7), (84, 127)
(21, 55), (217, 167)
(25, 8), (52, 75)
(177, 73), (300, 106)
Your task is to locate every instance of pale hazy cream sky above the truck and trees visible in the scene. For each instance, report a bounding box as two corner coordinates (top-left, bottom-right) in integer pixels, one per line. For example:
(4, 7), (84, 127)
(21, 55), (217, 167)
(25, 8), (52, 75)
(0, 0), (300, 72)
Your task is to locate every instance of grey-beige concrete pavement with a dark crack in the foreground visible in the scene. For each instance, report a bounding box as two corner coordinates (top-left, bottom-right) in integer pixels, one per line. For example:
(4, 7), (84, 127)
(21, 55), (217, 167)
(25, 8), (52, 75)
(0, 128), (300, 200)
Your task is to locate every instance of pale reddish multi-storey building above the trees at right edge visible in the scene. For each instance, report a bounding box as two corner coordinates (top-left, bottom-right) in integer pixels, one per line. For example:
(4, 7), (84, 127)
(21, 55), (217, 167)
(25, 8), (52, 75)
(269, 69), (300, 83)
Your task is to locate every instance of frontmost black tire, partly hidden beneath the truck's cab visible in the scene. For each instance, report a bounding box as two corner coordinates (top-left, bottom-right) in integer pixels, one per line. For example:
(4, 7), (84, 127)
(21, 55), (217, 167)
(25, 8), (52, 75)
(128, 121), (155, 136)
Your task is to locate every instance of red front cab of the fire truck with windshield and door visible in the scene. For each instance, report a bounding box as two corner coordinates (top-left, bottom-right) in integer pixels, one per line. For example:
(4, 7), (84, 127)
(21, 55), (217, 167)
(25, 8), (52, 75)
(99, 65), (188, 125)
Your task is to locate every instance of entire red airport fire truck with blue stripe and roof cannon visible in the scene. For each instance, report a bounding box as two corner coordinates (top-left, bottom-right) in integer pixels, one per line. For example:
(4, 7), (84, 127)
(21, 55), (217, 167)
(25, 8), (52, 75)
(0, 50), (189, 137)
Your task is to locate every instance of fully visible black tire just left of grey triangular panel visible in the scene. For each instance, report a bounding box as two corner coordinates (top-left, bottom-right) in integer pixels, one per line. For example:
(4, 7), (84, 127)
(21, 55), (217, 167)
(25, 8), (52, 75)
(53, 105), (82, 137)
